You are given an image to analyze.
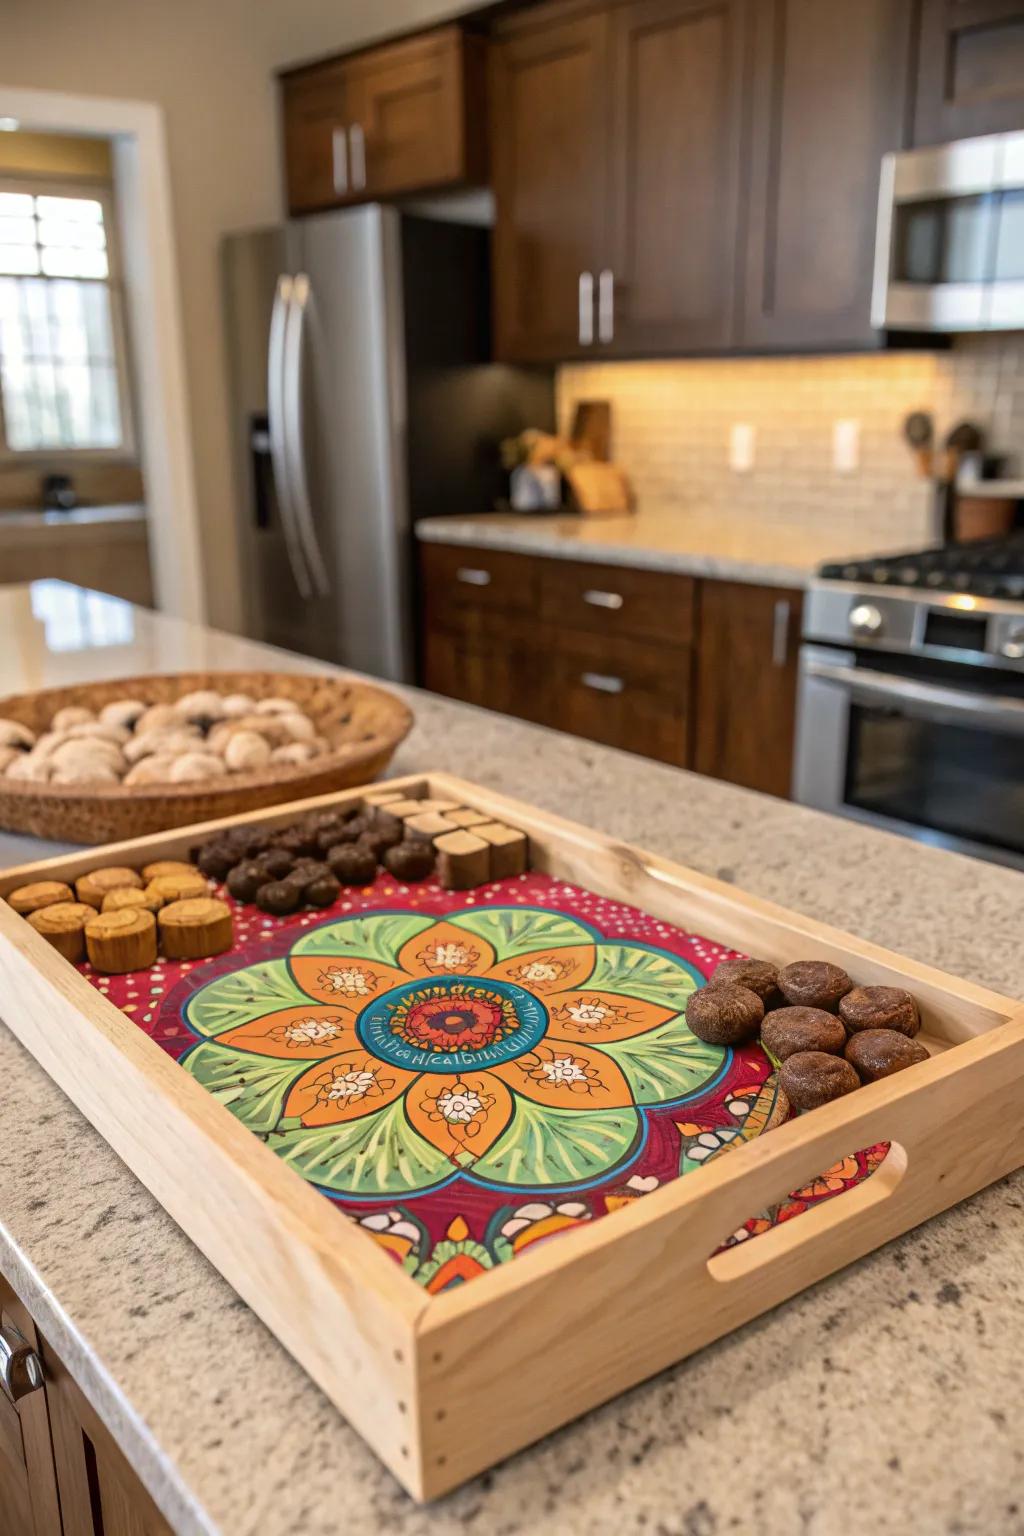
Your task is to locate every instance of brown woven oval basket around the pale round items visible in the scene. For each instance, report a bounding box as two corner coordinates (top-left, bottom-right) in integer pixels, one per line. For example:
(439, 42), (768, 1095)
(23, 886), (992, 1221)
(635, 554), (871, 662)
(0, 671), (413, 843)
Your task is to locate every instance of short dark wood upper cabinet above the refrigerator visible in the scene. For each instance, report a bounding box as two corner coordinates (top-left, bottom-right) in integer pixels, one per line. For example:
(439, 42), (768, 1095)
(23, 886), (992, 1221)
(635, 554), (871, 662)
(282, 26), (487, 214)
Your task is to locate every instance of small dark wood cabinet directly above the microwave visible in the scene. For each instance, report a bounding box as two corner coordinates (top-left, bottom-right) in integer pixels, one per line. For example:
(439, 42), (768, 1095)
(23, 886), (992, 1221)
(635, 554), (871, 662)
(913, 0), (1024, 144)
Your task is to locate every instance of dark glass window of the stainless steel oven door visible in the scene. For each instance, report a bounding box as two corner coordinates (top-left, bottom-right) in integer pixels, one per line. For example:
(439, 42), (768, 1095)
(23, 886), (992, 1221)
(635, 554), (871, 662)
(846, 702), (1024, 854)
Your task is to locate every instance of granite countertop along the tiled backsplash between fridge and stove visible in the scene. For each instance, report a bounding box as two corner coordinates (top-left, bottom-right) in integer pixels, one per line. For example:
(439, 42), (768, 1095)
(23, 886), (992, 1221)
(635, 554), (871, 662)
(416, 507), (906, 587)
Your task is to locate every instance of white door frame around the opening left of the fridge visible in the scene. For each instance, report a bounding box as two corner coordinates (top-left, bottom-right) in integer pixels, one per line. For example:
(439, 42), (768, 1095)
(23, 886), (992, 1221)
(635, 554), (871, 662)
(0, 84), (206, 624)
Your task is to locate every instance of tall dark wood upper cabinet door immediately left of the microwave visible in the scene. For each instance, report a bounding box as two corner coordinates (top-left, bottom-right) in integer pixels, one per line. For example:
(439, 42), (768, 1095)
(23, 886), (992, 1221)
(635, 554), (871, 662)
(740, 0), (915, 347)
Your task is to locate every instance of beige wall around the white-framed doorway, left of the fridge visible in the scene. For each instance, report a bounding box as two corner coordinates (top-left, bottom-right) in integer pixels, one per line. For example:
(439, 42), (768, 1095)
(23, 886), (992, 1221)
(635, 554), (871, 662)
(0, 0), (470, 628)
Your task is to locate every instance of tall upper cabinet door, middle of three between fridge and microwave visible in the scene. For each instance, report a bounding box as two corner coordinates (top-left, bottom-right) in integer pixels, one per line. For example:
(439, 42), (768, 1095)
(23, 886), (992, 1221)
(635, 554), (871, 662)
(599, 0), (745, 353)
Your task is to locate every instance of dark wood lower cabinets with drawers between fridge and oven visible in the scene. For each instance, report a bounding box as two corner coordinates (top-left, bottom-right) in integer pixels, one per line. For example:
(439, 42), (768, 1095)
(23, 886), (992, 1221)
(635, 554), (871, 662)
(421, 544), (801, 796)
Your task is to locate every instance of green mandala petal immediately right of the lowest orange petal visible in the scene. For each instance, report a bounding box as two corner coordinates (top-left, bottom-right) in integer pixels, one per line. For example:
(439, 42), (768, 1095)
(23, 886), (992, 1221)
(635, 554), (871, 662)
(473, 1095), (640, 1189)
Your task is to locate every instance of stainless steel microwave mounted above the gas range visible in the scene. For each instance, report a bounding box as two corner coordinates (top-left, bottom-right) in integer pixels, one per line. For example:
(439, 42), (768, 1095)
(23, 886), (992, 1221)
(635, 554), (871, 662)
(870, 132), (1024, 330)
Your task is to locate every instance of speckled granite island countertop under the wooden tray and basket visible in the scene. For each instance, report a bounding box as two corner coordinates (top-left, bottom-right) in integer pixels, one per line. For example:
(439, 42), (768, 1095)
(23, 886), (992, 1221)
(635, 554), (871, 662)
(0, 584), (1024, 1536)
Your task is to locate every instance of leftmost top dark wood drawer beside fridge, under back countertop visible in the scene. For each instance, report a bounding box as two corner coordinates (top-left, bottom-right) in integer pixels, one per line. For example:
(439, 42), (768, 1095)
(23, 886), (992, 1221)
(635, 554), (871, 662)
(421, 544), (539, 628)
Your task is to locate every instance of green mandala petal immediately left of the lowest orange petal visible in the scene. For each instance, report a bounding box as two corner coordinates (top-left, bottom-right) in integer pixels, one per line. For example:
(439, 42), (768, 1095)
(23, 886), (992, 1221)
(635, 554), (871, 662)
(269, 1098), (453, 1195)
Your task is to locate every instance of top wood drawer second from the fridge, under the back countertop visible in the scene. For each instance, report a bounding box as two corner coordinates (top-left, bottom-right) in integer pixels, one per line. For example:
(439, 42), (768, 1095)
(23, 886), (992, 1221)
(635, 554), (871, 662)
(540, 561), (694, 645)
